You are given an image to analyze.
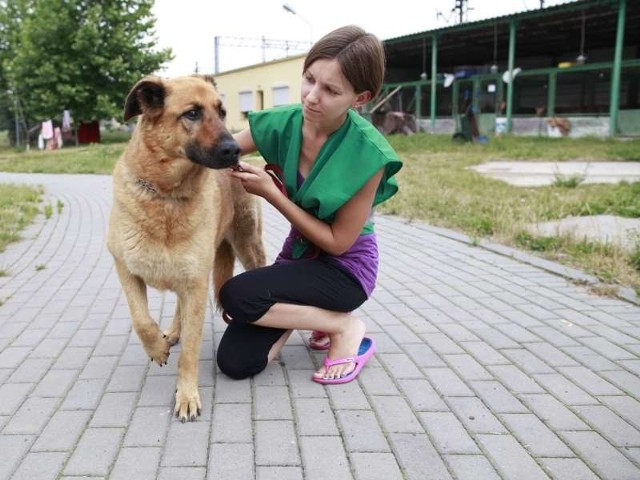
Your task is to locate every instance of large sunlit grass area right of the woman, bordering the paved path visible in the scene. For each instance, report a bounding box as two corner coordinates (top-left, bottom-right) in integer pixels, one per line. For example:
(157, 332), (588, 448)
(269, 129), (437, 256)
(380, 134), (640, 294)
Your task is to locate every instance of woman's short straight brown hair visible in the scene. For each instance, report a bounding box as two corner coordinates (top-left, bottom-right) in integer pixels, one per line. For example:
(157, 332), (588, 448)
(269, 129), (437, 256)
(303, 25), (385, 97)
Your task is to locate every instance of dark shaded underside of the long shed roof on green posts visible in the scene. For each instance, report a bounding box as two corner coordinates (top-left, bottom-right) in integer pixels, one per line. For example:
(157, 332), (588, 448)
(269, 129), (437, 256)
(384, 0), (640, 72)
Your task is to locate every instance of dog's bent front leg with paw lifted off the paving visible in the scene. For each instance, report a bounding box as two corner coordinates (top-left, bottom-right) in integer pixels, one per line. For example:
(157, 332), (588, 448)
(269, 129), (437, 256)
(115, 259), (170, 365)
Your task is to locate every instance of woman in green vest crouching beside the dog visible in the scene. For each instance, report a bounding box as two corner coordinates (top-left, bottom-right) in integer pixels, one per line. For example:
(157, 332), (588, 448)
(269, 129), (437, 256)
(217, 26), (402, 384)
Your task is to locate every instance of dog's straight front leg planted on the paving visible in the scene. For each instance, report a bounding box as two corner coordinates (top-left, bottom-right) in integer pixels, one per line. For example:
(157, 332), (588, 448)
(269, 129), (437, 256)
(174, 277), (209, 422)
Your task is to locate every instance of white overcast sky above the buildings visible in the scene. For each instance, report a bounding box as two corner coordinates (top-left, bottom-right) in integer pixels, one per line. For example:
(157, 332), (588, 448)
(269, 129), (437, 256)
(153, 0), (571, 77)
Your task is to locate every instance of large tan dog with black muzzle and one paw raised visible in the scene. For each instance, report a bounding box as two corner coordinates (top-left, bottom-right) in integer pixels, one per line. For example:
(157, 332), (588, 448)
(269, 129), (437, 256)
(107, 76), (265, 422)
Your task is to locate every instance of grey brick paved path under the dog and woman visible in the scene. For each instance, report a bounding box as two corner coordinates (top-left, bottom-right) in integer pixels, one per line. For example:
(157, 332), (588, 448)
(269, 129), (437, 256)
(0, 174), (640, 480)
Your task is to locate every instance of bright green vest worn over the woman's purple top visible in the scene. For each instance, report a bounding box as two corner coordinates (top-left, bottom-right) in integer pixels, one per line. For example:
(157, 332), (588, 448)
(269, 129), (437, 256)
(249, 104), (402, 257)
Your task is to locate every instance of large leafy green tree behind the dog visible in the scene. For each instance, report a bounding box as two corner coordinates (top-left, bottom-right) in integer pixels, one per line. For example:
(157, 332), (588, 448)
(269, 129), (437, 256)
(0, 0), (171, 130)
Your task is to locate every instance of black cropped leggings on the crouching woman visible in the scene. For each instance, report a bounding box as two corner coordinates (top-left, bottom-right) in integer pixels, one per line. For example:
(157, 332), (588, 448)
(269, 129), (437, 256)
(217, 258), (367, 379)
